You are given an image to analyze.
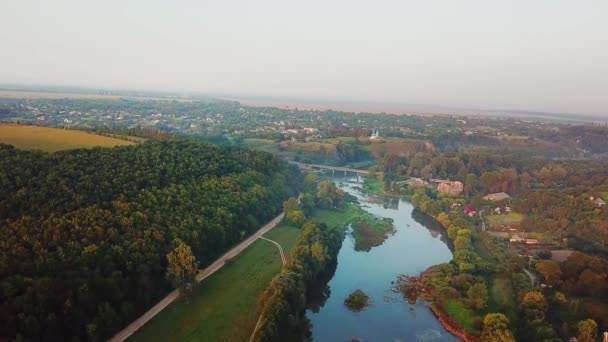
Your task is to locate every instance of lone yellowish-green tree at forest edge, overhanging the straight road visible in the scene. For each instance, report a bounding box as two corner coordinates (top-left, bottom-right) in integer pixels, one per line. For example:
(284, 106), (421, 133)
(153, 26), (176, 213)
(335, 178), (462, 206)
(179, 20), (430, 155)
(167, 239), (198, 288)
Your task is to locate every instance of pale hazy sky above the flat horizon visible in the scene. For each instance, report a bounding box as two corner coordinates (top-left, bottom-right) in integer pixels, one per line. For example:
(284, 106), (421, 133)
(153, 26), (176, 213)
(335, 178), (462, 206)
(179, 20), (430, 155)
(0, 0), (608, 116)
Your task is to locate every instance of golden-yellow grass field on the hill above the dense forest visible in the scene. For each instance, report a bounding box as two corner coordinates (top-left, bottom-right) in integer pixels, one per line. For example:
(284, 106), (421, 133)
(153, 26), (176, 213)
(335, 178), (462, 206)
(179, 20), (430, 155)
(0, 124), (135, 152)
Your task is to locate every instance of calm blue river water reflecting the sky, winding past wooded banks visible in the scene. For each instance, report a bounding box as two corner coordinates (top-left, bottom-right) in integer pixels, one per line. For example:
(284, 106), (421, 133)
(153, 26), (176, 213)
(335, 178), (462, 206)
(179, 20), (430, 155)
(307, 178), (458, 342)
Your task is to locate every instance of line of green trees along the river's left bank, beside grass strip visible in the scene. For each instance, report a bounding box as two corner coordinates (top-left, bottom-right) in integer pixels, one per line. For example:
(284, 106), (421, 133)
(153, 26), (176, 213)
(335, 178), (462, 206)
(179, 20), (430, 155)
(253, 174), (348, 342)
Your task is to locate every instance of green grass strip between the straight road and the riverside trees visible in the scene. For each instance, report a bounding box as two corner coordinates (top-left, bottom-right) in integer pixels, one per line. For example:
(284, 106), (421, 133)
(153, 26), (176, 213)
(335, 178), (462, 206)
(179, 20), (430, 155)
(130, 225), (300, 342)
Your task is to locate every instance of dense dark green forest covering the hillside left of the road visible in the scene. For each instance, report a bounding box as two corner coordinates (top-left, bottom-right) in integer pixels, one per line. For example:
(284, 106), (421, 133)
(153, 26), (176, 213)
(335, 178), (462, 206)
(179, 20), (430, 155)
(0, 141), (300, 341)
